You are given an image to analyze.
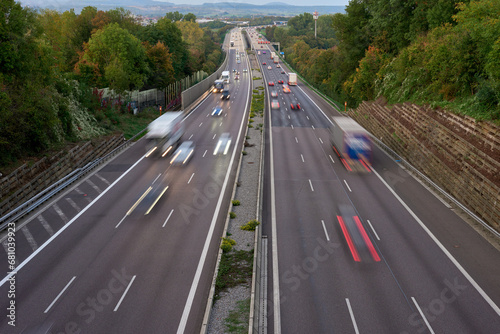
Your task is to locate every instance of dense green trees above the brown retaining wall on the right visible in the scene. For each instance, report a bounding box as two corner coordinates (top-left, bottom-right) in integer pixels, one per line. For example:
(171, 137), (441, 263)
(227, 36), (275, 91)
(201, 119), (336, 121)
(265, 0), (500, 123)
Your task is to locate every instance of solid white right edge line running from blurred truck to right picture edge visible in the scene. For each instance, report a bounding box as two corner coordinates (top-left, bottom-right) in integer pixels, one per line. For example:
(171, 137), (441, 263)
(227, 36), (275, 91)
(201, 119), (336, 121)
(372, 167), (500, 316)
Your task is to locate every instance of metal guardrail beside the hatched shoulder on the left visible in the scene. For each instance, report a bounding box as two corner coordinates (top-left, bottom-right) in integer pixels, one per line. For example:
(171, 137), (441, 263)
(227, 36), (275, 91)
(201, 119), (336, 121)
(0, 128), (147, 231)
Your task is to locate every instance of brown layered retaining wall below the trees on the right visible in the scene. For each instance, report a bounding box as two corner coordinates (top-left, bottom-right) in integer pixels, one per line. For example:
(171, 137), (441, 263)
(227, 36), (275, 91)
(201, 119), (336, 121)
(349, 102), (500, 231)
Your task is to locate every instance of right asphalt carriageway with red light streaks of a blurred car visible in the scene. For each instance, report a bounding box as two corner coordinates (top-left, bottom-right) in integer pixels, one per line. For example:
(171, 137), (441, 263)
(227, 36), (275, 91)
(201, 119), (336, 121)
(249, 29), (500, 333)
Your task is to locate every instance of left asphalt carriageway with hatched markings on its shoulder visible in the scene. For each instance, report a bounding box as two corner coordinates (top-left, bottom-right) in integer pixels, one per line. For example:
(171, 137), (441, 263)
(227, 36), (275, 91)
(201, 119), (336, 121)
(0, 33), (252, 333)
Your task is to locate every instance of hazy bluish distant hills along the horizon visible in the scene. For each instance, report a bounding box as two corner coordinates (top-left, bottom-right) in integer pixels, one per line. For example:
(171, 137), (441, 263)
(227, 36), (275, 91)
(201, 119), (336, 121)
(20, 0), (345, 18)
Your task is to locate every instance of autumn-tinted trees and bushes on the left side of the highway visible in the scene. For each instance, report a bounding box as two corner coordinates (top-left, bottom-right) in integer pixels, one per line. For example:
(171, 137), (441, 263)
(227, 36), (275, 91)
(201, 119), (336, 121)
(0, 0), (225, 166)
